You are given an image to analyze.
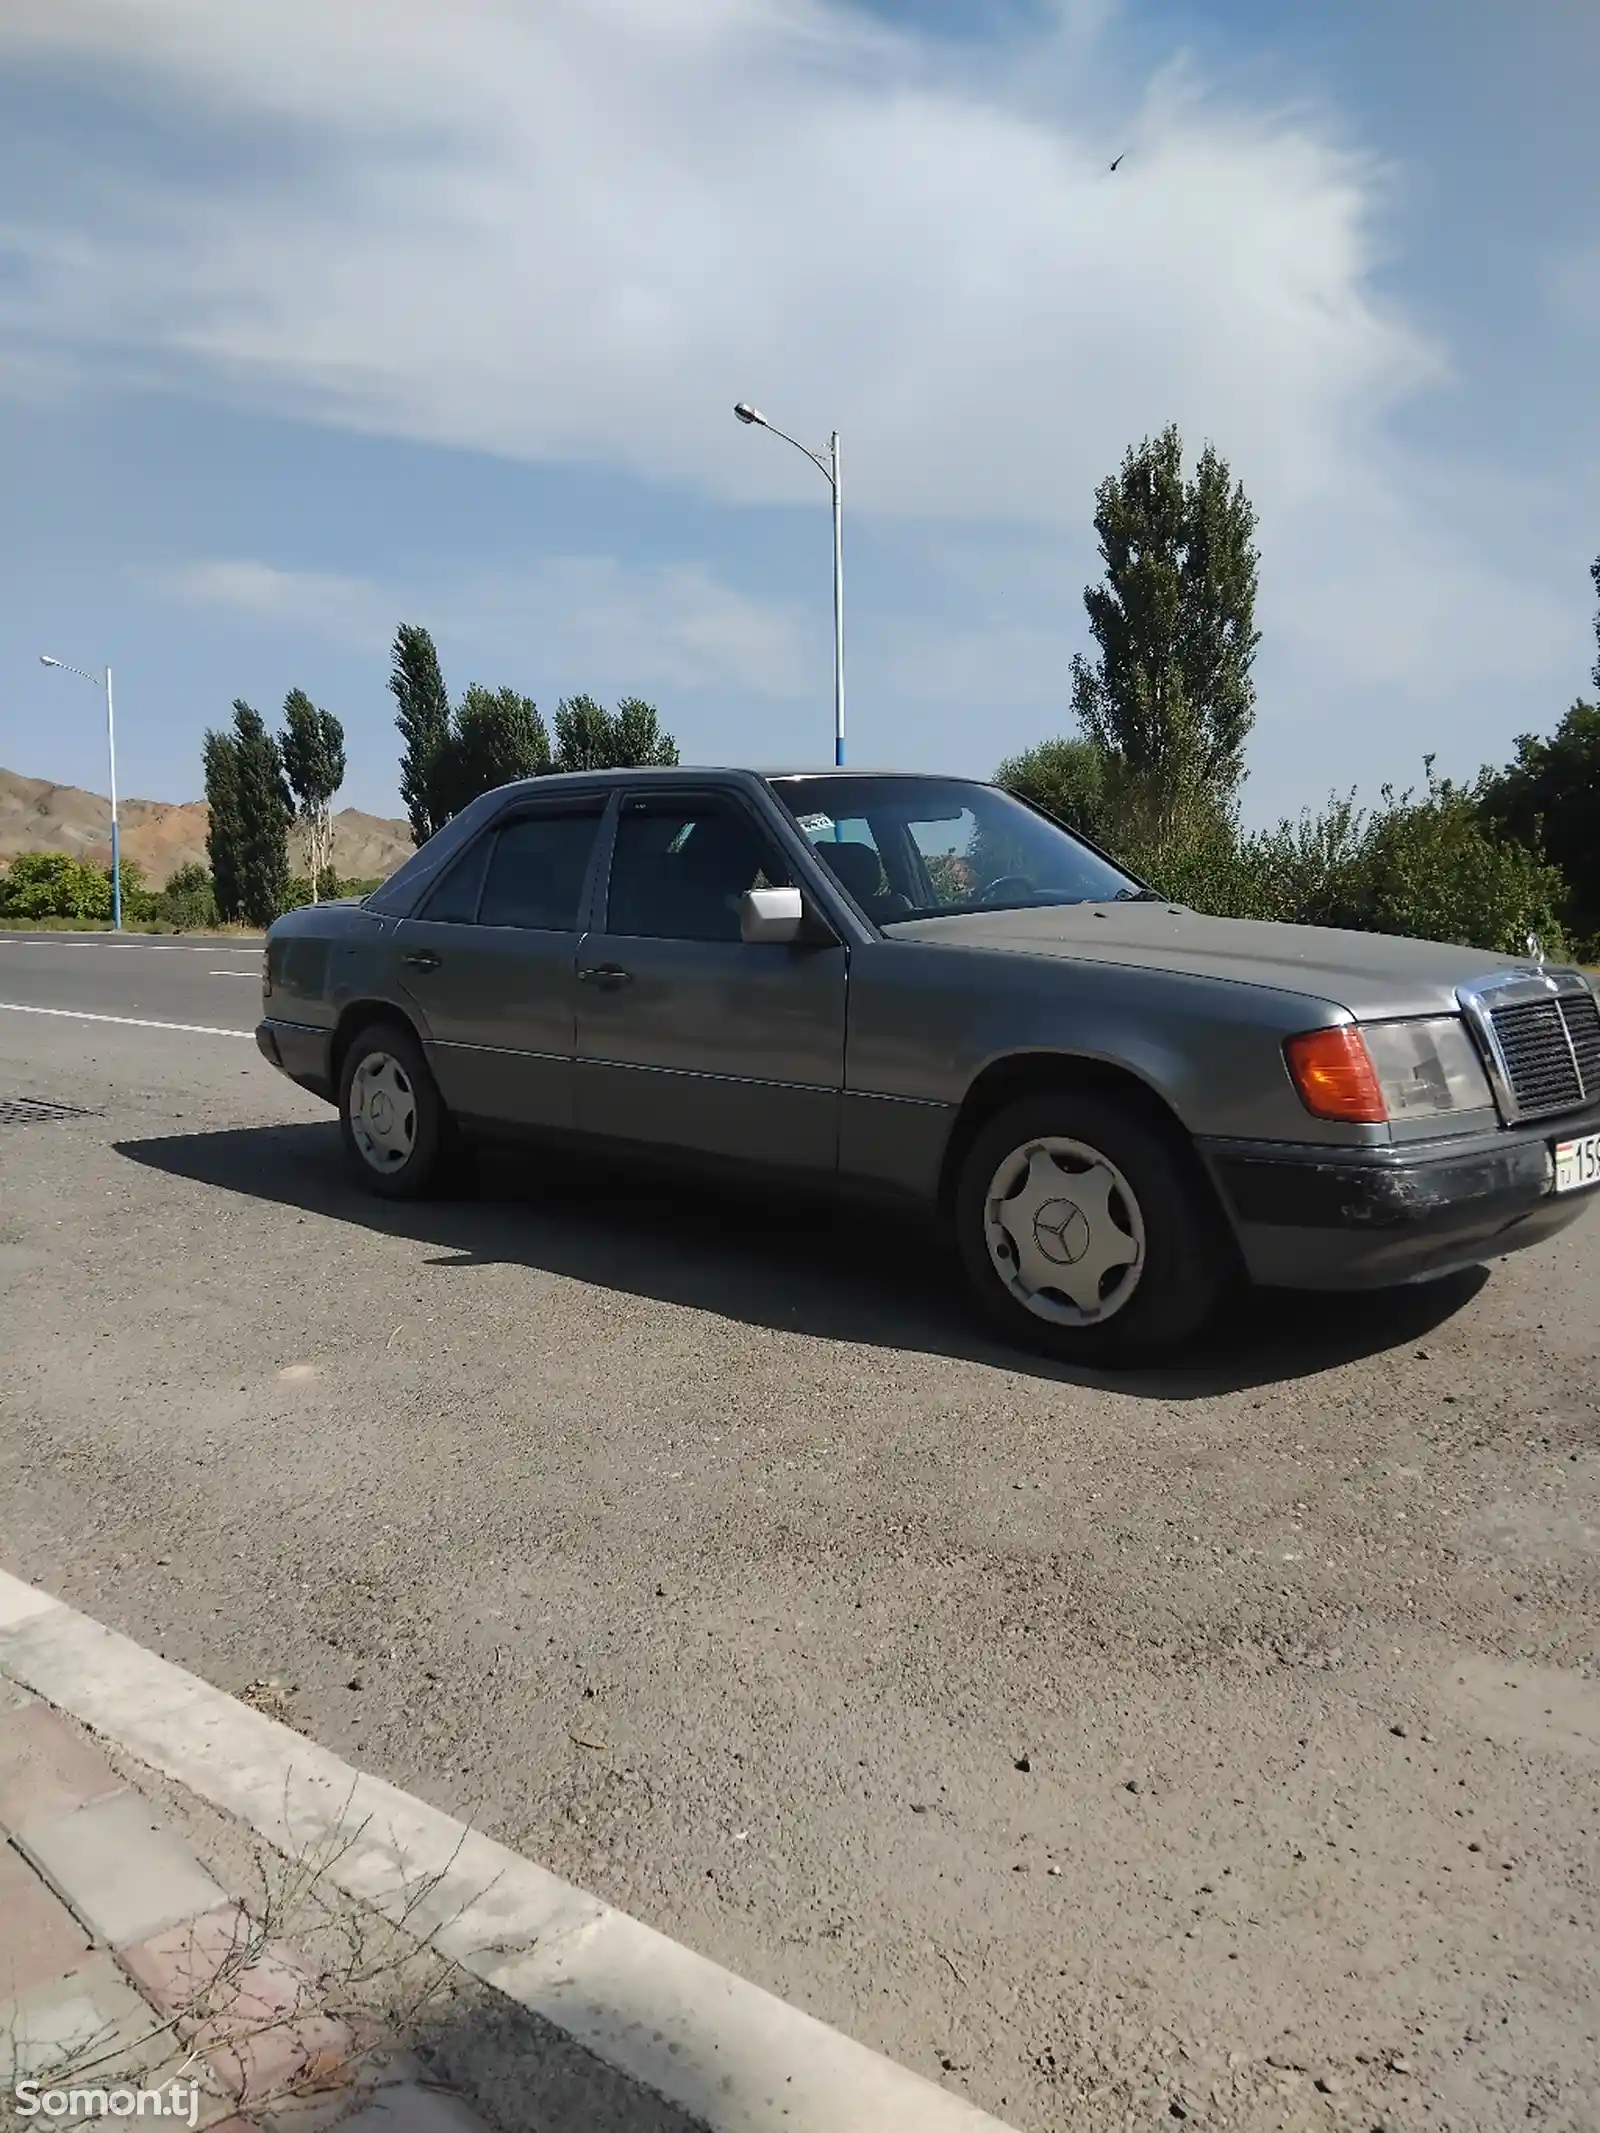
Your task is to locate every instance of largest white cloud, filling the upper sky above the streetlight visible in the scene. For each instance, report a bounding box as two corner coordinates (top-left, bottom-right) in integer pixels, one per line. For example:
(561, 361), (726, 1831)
(0, 0), (1436, 520)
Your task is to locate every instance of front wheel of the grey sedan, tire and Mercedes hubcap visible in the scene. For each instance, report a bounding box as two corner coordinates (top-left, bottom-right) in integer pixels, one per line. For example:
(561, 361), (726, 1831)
(956, 1088), (1235, 1367)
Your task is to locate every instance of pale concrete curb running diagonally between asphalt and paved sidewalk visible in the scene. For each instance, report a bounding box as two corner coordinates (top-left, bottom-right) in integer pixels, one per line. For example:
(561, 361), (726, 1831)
(0, 1570), (1007, 2133)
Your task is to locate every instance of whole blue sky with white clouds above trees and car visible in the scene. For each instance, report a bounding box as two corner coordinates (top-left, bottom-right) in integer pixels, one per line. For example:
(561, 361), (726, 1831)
(0, 0), (1600, 821)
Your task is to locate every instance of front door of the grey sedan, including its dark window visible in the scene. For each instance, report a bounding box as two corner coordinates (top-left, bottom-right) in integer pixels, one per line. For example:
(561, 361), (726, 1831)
(576, 793), (847, 1171)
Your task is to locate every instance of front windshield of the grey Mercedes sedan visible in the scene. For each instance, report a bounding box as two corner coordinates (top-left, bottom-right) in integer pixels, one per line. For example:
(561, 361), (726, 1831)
(768, 774), (1143, 926)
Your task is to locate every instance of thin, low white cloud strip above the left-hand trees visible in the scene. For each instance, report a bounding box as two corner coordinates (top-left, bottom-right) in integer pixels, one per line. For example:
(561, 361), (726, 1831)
(141, 557), (821, 697)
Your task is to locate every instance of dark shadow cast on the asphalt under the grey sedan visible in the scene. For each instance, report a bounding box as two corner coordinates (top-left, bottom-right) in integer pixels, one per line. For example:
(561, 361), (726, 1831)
(115, 1122), (1487, 1399)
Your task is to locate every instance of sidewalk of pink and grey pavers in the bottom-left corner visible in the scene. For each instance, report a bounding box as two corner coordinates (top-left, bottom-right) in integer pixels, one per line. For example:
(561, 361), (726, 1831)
(0, 1674), (486, 2133)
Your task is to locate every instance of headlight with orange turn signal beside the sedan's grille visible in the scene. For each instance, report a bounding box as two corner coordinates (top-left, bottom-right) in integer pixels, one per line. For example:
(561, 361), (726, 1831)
(1284, 1015), (1493, 1126)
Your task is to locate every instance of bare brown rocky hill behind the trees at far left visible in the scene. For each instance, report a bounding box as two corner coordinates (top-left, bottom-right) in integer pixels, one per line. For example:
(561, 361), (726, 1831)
(0, 770), (412, 889)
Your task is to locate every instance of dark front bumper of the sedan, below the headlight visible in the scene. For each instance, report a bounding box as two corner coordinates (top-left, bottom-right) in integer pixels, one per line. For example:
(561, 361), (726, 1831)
(1203, 1107), (1600, 1288)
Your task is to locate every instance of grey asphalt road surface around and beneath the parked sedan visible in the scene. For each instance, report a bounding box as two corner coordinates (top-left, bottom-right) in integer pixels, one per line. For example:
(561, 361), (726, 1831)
(0, 939), (1600, 2133)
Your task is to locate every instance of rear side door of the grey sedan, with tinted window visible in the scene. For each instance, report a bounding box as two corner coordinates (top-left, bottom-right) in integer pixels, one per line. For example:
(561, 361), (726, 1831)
(395, 793), (606, 1130)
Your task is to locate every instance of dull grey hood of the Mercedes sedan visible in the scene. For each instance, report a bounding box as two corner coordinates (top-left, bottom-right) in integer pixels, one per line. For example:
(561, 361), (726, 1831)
(883, 902), (1521, 1017)
